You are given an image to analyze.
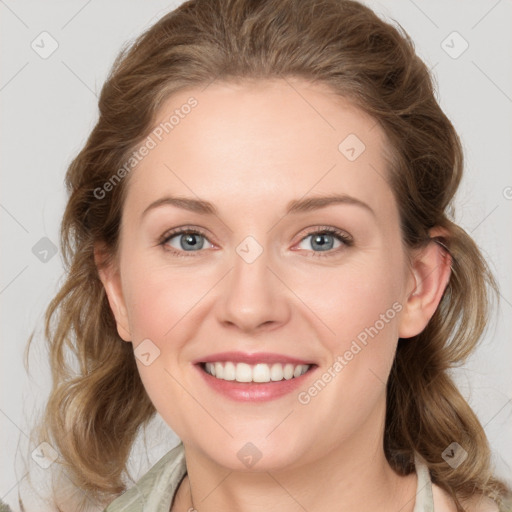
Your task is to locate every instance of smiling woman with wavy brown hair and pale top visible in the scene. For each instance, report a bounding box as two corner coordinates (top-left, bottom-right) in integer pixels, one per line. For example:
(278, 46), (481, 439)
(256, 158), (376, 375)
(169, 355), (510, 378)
(29, 0), (510, 512)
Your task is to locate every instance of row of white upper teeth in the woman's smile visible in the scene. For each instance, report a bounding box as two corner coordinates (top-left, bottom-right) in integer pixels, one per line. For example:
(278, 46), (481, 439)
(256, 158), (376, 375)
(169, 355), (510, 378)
(205, 361), (310, 382)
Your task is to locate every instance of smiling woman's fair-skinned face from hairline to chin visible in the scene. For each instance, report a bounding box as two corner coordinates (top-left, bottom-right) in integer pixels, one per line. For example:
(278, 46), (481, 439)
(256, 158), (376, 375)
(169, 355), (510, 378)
(102, 80), (430, 470)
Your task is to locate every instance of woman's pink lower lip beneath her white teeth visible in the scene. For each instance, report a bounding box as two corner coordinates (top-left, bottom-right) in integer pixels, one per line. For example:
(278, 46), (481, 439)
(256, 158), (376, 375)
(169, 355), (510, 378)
(194, 364), (318, 402)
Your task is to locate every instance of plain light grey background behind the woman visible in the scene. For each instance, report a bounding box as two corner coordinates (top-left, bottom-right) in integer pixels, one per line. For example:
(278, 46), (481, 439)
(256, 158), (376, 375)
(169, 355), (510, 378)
(0, 0), (512, 510)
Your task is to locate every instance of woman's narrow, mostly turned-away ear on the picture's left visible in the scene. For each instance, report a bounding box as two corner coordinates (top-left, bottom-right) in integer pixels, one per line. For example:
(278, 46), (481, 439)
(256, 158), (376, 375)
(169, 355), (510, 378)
(94, 243), (131, 341)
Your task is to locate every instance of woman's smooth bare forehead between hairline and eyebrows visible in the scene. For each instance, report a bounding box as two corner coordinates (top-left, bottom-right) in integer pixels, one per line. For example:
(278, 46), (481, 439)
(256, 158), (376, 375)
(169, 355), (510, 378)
(122, 78), (391, 222)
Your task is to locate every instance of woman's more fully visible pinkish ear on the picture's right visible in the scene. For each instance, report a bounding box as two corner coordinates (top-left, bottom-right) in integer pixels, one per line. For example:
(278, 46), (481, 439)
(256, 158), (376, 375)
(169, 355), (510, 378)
(399, 228), (452, 338)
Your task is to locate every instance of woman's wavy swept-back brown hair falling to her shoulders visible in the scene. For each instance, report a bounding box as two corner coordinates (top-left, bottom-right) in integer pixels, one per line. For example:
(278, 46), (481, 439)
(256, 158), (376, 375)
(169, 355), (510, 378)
(29, 0), (508, 510)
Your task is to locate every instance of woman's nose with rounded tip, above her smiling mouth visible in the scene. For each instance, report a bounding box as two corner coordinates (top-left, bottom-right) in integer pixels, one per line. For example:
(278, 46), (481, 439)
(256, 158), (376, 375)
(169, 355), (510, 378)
(217, 243), (291, 333)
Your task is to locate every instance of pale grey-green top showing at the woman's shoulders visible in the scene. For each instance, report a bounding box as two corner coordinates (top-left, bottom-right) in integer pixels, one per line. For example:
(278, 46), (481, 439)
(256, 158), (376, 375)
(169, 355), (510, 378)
(104, 442), (434, 512)
